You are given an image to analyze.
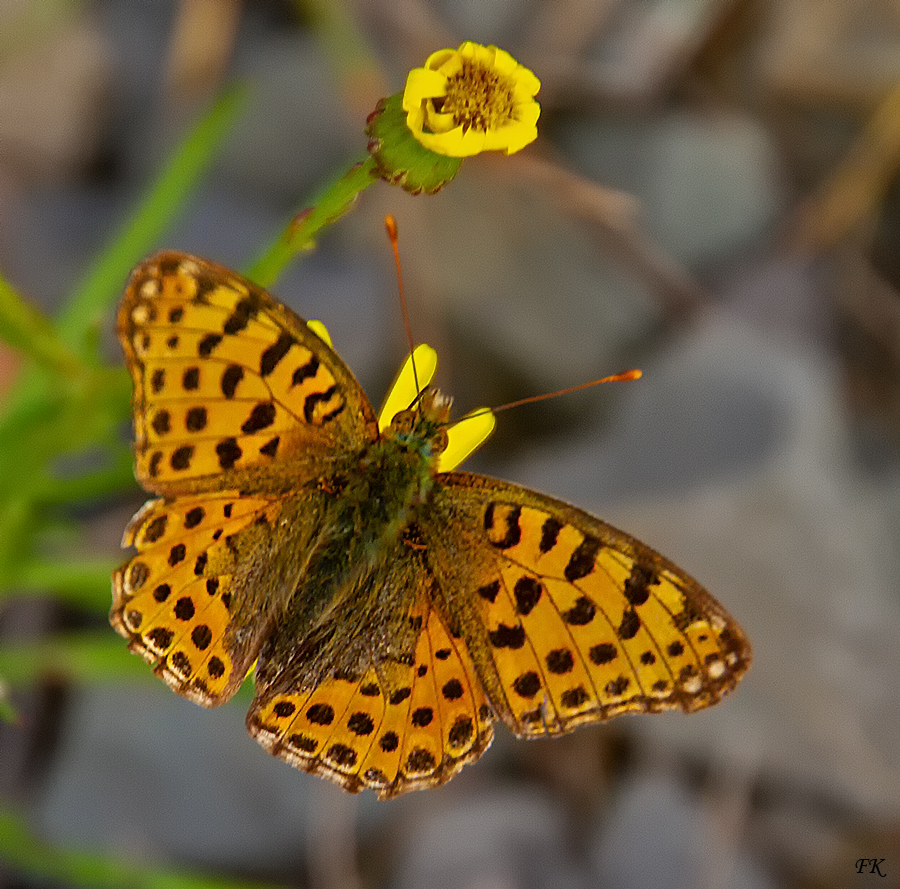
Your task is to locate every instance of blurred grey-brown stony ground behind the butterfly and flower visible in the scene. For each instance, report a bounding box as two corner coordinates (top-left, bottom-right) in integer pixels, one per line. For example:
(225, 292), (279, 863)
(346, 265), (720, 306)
(0, 0), (900, 889)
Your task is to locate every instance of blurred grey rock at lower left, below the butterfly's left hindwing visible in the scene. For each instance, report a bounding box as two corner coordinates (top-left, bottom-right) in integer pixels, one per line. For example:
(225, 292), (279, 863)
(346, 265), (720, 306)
(34, 684), (326, 873)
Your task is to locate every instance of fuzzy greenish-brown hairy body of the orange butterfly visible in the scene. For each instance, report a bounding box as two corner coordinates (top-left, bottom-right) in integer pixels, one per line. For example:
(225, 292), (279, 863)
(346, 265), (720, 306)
(250, 412), (442, 682)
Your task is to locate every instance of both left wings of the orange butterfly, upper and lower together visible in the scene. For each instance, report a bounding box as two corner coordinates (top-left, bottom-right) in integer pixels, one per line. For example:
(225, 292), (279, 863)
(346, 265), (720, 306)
(110, 253), (378, 707)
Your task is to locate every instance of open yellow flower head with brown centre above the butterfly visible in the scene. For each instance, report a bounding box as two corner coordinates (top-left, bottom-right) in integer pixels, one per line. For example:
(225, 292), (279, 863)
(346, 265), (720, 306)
(403, 41), (541, 157)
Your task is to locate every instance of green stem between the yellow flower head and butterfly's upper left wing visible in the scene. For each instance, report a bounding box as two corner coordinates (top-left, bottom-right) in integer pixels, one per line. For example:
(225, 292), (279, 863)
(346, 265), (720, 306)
(246, 155), (377, 287)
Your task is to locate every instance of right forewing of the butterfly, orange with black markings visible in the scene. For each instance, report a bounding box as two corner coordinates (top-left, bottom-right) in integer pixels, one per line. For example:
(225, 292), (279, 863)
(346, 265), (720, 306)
(422, 473), (750, 736)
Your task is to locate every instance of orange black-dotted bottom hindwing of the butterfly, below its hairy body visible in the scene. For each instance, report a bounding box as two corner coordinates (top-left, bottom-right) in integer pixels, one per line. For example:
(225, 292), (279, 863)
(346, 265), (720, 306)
(247, 599), (493, 799)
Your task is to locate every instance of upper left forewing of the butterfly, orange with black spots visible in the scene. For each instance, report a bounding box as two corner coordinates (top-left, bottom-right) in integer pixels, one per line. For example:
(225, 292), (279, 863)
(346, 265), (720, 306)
(118, 253), (377, 493)
